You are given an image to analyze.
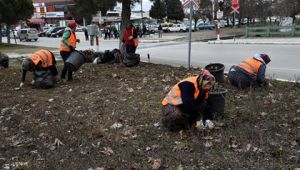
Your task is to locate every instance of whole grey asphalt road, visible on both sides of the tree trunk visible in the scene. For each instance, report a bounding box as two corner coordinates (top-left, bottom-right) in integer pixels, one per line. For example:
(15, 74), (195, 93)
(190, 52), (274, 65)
(5, 33), (300, 81)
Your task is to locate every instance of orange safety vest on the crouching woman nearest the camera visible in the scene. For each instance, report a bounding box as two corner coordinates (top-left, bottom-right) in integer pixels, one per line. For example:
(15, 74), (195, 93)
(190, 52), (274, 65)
(162, 76), (208, 106)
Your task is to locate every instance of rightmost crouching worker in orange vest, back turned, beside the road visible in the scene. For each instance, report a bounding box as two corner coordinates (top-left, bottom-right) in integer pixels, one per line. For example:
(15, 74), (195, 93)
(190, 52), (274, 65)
(228, 54), (271, 89)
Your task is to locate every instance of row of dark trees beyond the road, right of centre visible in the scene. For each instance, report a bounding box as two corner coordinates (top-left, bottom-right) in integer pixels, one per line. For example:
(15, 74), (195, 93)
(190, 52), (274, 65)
(150, 0), (300, 24)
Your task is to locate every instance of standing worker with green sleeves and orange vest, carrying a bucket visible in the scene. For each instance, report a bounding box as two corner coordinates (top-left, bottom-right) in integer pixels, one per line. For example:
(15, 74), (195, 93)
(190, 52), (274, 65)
(60, 21), (80, 82)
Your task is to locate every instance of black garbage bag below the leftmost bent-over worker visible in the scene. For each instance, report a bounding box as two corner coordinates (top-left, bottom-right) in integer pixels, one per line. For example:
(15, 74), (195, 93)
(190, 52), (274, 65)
(34, 70), (55, 89)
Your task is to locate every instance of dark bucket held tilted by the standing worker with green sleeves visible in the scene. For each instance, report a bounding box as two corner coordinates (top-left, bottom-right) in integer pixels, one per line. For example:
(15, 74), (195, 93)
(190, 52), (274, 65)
(66, 51), (85, 71)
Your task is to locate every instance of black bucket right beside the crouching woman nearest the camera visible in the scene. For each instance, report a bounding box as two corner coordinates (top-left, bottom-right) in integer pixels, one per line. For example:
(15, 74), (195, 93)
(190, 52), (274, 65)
(208, 88), (227, 118)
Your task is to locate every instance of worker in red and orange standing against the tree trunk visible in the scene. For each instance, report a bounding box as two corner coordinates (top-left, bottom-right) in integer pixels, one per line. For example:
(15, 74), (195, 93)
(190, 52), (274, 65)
(123, 23), (139, 54)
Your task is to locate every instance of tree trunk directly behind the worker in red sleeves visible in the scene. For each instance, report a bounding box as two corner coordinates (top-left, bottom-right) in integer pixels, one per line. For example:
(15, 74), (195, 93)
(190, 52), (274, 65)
(120, 0), (131, 47)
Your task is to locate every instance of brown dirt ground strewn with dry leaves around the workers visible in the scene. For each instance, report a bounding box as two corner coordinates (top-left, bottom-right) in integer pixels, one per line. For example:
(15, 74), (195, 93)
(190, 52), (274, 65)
(0, 60), (300, 170)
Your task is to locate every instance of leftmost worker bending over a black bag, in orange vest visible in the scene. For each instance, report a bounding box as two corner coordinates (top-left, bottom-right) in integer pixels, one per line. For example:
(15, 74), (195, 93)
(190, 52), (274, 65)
(20, 50), (58, 89)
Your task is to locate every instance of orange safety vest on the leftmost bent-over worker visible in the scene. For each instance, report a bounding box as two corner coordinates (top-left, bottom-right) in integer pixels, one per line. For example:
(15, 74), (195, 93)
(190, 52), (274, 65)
(29, 50), (53, 68)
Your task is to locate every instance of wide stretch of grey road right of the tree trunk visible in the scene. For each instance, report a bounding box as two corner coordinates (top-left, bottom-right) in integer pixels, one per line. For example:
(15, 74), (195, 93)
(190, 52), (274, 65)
(138, 42), (300, 81)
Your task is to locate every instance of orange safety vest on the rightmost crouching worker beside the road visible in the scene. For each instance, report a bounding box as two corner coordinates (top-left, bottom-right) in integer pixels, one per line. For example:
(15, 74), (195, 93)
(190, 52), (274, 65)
(238, 58), (262, 76)
